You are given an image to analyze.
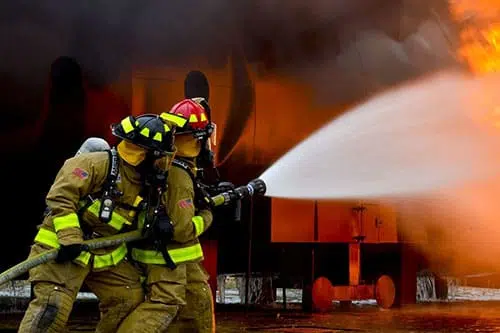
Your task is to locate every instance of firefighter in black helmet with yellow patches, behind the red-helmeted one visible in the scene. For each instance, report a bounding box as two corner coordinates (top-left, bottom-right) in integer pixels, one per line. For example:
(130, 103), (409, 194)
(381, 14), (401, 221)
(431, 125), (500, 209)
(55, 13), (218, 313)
(19, 114), (182, 333)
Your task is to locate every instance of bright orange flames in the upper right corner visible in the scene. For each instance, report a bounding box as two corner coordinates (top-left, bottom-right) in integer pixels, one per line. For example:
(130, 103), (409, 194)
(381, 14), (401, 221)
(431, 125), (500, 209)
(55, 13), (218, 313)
(450, 0), (500, 73)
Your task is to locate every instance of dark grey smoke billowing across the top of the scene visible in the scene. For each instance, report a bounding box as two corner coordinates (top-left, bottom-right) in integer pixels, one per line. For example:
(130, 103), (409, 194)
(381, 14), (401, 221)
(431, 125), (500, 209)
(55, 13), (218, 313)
(0, 0), (458, 89)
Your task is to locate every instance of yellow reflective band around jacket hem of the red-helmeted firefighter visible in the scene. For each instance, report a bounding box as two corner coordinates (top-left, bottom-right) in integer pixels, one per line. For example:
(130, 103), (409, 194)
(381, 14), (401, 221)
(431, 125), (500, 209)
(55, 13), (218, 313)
(132, 243), (203, 265)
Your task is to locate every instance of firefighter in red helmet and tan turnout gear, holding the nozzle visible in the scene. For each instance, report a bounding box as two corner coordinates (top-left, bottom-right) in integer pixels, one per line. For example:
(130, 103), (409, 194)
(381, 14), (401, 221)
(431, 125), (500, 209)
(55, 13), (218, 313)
(118, 99), (214, 333)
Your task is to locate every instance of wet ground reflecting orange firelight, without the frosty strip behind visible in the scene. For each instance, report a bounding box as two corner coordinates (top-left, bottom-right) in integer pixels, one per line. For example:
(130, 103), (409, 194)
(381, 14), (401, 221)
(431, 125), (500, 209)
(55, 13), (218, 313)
(0, 302), (500, 333)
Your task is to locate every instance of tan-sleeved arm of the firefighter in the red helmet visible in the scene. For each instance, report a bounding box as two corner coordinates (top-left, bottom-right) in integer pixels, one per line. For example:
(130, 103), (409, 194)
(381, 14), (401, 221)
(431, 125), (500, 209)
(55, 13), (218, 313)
(165, 175), (212, 243)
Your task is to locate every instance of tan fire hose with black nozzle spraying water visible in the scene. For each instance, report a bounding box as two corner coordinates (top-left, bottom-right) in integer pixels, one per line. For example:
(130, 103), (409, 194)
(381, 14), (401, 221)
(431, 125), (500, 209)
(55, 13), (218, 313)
(0, 179), (266, 286)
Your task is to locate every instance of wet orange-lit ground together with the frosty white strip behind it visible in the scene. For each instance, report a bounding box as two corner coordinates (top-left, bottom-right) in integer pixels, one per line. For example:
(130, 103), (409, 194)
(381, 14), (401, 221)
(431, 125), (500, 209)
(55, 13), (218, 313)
(0, 283), (500, 333)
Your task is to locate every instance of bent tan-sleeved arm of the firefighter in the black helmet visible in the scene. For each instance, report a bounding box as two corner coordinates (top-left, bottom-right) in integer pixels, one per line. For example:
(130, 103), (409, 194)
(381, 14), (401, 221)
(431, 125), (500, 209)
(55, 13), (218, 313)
(46, 156), (104, 245)
